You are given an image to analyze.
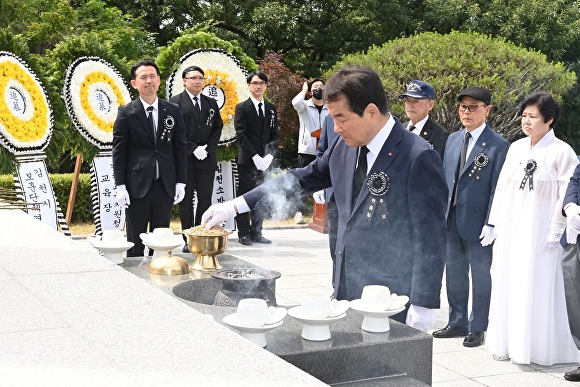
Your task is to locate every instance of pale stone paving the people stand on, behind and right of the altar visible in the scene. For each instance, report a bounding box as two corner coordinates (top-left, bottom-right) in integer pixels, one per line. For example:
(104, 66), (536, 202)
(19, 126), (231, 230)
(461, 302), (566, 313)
(228, 228), (580, 387)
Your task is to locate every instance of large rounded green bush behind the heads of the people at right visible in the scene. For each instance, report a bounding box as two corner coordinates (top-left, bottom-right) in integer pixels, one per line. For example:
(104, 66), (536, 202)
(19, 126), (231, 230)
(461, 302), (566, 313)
(330, 31), (576, 141)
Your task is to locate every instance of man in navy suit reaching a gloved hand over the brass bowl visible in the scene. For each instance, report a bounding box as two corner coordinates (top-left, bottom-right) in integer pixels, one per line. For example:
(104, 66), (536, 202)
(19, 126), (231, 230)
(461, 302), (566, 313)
(203, 66), (447, 331)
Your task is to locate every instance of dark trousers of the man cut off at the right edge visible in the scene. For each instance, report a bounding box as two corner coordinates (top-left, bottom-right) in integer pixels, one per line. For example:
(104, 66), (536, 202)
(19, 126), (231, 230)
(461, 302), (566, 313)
(562, 244), (580, 349)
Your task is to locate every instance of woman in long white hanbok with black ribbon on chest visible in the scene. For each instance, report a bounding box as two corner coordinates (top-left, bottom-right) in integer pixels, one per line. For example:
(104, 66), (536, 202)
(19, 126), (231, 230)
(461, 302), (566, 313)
(485, 92), (580, 365)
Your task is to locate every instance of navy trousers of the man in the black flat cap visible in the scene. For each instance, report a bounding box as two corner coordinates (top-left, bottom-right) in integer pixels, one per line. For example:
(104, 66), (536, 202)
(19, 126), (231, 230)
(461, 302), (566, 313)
(445, 206), (493, 332)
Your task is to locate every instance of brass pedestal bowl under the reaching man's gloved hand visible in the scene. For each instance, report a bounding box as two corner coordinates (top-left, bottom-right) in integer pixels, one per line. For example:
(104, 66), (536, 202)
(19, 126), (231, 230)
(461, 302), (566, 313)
(183, 226), (232, 271)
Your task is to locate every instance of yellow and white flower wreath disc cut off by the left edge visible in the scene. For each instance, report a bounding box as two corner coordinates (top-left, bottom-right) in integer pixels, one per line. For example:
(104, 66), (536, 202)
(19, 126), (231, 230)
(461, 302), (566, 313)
(0, 52), (52, 153)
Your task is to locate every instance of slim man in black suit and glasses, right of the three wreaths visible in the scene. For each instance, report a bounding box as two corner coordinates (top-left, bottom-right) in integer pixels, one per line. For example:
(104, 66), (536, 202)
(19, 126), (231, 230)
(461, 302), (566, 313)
(234, 71), (278, 246)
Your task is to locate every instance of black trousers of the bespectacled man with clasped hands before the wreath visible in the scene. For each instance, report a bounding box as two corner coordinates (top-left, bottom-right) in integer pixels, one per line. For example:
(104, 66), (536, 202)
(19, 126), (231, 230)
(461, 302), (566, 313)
(179, 160), (215, 241)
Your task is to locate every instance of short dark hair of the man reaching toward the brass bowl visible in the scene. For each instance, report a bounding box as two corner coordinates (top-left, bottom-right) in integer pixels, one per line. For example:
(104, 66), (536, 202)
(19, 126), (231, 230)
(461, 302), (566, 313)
(324, 66), (389, 117)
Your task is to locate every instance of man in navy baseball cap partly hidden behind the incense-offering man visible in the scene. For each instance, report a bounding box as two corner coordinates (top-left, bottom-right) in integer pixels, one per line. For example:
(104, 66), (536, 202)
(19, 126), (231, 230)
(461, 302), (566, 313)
(399, 80), (449, 160)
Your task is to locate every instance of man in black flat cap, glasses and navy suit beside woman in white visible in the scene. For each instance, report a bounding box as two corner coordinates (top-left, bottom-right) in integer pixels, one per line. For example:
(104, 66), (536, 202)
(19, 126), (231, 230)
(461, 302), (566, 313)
(433, 87), (509, 347)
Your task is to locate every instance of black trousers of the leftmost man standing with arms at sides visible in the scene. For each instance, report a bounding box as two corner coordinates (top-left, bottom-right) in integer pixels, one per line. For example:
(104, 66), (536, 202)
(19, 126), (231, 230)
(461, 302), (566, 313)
(125, 178), (173, 257)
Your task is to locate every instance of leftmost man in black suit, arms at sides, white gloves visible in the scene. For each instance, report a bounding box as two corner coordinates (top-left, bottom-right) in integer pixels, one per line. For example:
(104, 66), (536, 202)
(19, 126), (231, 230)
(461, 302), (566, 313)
(113, 60), (187, 257)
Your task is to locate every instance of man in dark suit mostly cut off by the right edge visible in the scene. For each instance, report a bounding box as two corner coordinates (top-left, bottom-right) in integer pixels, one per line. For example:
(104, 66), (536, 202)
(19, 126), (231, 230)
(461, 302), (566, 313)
(560, 165), (580, 382)
